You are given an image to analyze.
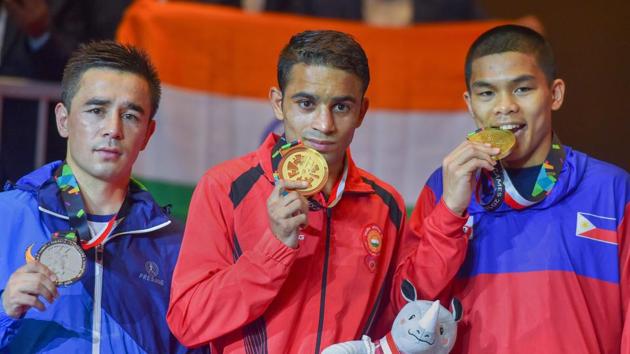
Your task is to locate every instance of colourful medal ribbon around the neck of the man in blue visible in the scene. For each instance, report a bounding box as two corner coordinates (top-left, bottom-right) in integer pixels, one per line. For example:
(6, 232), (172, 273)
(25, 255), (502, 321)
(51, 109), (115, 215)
(53, 162), (126, 250)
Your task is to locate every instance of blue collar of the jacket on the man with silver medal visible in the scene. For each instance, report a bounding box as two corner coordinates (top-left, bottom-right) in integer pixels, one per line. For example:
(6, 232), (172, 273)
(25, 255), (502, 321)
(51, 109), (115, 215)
(15, 161), (170, 235)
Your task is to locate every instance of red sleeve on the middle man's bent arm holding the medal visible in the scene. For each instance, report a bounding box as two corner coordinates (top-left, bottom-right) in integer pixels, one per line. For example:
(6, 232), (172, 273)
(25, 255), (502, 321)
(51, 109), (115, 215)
(167, 174), (297, 347)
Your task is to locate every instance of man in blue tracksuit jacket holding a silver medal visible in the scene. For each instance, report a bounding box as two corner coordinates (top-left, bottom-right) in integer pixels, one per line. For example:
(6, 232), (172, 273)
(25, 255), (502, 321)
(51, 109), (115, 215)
(0, 42), (205, 354)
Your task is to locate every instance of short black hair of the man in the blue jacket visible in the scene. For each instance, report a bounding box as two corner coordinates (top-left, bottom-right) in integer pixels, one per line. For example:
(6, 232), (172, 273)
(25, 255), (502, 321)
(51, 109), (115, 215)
(61, 41), (162, 118)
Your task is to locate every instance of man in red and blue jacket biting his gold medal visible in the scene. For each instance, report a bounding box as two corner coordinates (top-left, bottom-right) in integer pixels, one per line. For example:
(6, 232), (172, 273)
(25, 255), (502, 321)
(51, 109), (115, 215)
(393, 25), (630, 354)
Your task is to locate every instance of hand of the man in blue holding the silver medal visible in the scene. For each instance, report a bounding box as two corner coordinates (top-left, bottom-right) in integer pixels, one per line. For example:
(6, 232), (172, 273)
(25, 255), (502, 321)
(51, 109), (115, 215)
(2, 261), (59, 319)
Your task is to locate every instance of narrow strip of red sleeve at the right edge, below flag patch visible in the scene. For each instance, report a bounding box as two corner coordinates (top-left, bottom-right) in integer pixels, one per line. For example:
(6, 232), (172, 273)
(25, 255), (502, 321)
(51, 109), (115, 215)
(618, 202), (630, 353)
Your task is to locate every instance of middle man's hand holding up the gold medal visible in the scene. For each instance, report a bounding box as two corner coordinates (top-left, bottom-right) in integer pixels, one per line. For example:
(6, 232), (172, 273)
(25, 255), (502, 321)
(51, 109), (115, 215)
(267, 180), (308, 248)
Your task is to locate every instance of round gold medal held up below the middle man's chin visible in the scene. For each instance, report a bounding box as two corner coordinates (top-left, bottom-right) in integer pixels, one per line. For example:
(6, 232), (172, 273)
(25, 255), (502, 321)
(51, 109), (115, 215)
(278, 145), (328, 197)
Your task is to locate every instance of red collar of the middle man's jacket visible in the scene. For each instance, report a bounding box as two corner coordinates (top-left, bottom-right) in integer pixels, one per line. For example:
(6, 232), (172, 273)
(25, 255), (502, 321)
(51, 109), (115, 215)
(256, 133), (374, 193)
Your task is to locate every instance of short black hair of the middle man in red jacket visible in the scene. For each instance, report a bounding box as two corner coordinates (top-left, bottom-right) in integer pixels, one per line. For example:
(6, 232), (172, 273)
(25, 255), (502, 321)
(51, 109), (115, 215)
(278, 30), (370, 93)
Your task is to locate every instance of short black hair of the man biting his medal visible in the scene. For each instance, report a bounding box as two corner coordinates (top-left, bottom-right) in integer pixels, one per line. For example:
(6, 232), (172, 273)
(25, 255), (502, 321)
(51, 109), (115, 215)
(464, 25), (556, 91)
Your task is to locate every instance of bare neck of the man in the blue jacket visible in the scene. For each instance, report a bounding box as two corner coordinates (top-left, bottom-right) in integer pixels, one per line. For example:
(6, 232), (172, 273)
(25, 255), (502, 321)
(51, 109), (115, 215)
(68, 161), (129, 215)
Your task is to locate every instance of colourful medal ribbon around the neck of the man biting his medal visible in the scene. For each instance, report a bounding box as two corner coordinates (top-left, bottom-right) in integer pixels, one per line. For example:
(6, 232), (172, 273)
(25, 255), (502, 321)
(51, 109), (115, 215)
(475, 134), (566, 211)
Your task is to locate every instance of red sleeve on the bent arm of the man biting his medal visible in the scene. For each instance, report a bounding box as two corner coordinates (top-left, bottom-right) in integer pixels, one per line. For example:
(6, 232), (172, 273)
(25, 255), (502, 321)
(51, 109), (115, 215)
(391, 185), (470, 310)
